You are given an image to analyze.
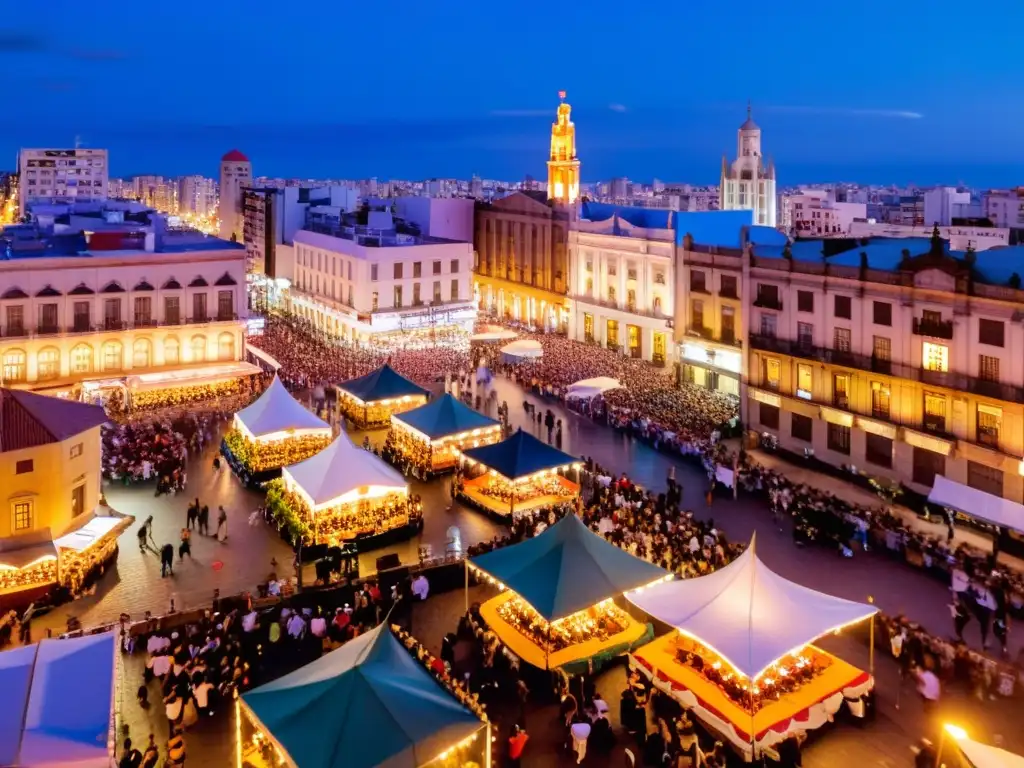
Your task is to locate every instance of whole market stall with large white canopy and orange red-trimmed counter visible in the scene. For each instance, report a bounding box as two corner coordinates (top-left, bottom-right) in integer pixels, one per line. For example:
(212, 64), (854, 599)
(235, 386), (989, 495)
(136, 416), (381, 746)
(627, 542), (877, 761)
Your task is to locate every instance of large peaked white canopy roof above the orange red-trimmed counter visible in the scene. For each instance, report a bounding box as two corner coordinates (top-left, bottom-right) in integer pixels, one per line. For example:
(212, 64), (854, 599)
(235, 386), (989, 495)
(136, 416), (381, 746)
(626, 541), (878, 679)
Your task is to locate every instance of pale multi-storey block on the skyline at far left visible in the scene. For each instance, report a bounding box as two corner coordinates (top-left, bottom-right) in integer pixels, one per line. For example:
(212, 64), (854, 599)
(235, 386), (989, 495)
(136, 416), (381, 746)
(17, 148), (110, 215)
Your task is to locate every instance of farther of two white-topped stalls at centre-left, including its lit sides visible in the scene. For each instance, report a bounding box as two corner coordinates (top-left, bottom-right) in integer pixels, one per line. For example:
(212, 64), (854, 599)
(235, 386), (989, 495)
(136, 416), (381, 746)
(221, 376), (333, 482)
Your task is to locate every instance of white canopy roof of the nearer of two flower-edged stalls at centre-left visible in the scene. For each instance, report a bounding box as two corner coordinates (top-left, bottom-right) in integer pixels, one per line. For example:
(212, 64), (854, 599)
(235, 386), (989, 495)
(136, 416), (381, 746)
(282, 431), (409, 512)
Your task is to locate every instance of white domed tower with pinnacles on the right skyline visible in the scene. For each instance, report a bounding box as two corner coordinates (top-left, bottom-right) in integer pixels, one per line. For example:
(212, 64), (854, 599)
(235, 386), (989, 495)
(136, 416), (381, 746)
(719, 106), (777, 226)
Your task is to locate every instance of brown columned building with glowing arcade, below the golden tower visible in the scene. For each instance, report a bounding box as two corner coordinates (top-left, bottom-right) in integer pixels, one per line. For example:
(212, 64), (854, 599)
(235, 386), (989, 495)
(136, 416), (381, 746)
(473, 193), (571, 333)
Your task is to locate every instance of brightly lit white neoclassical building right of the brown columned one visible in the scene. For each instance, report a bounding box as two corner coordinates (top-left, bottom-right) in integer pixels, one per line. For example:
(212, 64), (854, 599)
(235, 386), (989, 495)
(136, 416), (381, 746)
(568, 203), (675, 365)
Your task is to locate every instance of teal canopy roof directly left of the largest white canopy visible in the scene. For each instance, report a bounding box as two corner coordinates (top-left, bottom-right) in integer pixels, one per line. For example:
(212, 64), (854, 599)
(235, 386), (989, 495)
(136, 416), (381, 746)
(470, 515), (669, 622)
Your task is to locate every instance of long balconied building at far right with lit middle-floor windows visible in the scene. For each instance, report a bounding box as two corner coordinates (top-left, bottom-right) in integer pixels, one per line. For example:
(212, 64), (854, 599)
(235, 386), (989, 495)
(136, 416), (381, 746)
(742, 236), (1024, 512)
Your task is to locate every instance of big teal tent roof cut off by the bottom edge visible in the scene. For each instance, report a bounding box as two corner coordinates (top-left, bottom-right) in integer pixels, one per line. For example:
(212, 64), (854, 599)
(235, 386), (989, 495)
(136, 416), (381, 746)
(242, 625), (483, 768)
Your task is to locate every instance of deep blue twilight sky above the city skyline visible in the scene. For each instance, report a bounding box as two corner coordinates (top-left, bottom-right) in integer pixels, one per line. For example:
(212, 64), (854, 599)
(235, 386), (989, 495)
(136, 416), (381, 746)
(0, 0), (1024, 186)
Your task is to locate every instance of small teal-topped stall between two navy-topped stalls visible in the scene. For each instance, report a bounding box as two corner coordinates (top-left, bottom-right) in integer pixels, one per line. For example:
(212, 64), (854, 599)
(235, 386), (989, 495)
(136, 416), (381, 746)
(384, 394), (502, 474)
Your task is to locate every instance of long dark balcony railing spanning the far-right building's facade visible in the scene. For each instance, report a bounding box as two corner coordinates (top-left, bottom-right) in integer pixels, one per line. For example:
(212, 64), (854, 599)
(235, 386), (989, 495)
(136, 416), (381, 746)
(750, 334), (1024, 402)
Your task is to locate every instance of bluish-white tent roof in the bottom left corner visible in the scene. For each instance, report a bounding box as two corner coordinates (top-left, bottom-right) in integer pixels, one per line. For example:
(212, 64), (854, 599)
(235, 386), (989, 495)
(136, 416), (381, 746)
(0, 632), (117, 768)
